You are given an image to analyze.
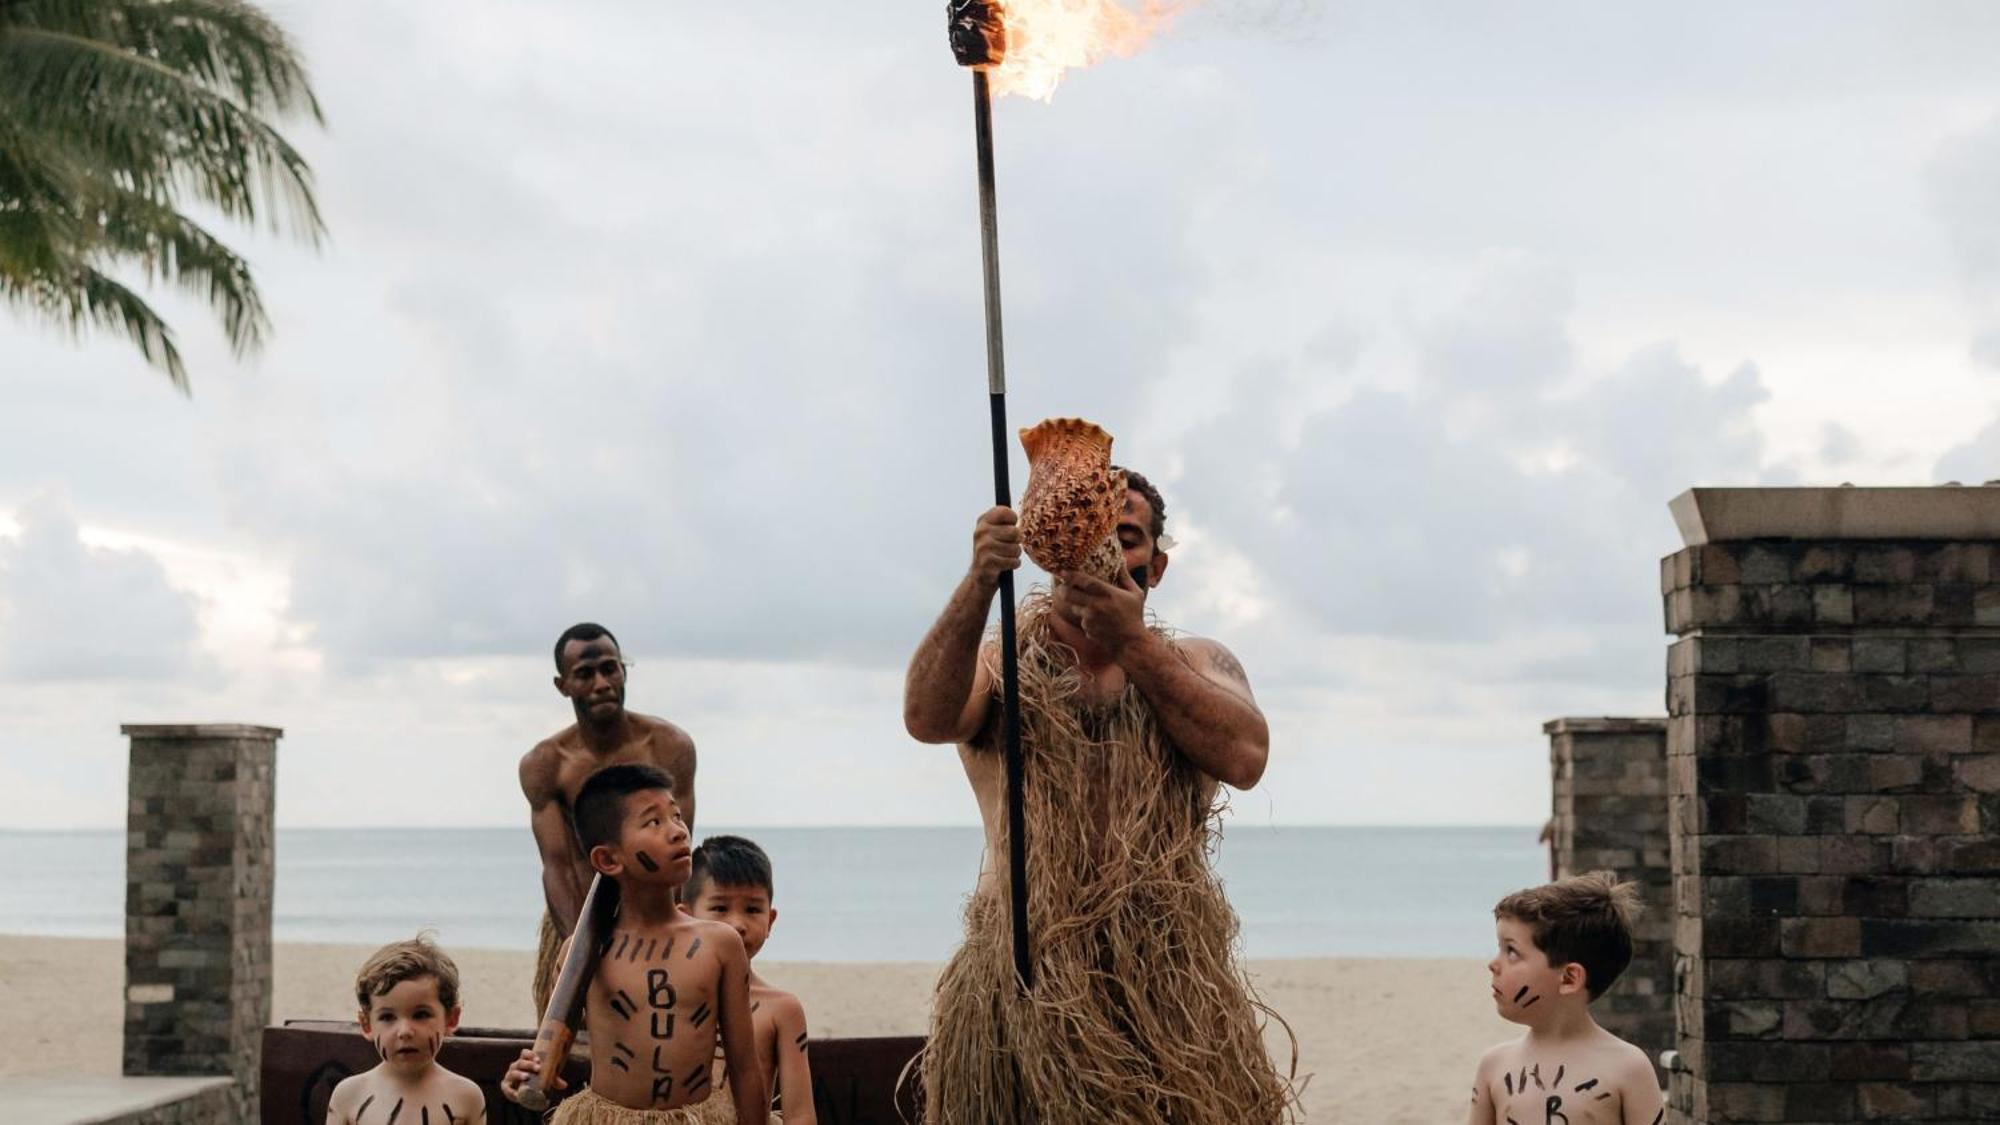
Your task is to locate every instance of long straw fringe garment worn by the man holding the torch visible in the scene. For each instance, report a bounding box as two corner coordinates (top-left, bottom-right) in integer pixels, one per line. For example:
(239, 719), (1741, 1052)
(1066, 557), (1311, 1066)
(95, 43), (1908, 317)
(920, 591), (1298, 1125)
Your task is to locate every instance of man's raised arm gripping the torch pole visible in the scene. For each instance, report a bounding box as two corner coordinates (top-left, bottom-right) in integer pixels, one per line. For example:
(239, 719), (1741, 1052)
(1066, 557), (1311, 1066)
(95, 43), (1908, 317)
(902, 508), (1020, 743)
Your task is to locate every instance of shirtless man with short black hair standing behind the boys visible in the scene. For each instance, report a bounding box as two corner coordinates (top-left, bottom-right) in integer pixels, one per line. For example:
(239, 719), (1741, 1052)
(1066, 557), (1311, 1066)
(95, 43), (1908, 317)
(520, 623), (694, 1013)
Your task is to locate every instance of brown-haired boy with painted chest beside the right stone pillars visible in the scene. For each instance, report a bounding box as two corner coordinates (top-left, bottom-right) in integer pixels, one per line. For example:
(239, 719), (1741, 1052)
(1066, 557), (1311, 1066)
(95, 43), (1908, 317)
(1466, 871), (1664, 1125)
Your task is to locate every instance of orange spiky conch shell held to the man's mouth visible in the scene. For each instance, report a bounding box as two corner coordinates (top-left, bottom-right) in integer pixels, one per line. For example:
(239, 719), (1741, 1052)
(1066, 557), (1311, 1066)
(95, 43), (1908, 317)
(1020, 418), (1126, 583)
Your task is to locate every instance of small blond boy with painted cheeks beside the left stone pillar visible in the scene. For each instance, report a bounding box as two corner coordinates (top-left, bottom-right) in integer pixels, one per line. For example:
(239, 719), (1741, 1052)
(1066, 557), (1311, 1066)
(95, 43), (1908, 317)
(326, 935), (486, 1125)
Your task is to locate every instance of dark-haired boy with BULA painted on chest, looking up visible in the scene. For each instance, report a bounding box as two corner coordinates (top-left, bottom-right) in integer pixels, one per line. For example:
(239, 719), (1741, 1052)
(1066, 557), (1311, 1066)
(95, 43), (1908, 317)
(500, 765), (770, 1125)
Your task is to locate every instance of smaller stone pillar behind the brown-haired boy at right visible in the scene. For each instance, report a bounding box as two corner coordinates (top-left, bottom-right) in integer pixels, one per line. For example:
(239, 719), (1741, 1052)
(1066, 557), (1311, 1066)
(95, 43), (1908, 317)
(1542, 719), (1674, 1085)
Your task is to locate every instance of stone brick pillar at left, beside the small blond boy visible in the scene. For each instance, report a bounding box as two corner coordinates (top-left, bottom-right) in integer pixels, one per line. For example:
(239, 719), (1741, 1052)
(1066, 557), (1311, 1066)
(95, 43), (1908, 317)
(122, 723), (282, 1121)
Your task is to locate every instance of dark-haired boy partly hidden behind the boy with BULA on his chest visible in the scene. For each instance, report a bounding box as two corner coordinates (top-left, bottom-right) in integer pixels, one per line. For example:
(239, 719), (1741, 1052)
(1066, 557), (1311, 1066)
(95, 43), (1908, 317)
(680, 837), (820, 1125)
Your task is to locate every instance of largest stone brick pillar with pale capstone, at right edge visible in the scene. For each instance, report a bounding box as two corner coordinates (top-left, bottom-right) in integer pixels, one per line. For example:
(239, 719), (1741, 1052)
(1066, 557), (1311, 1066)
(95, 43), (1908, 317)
(1662, 488), (2000, 1125)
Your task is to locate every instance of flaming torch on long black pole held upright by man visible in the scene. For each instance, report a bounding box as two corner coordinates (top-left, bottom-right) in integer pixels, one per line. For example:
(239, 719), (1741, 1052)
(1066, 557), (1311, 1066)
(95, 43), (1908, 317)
(944, 0), (1172, 989)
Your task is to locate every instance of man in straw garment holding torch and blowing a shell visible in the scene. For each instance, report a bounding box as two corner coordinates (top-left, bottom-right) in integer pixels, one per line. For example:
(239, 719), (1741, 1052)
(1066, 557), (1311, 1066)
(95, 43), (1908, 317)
(904, 470), (1294, 1125)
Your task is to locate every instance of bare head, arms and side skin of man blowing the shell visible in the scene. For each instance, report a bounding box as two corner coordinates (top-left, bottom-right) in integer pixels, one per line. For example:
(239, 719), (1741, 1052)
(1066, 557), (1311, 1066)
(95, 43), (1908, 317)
(902, 470), (1270, 887)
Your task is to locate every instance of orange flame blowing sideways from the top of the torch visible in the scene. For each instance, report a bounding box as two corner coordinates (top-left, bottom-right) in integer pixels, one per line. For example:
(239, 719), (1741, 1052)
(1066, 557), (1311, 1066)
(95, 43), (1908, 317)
(988, 0), (1176, 102)
